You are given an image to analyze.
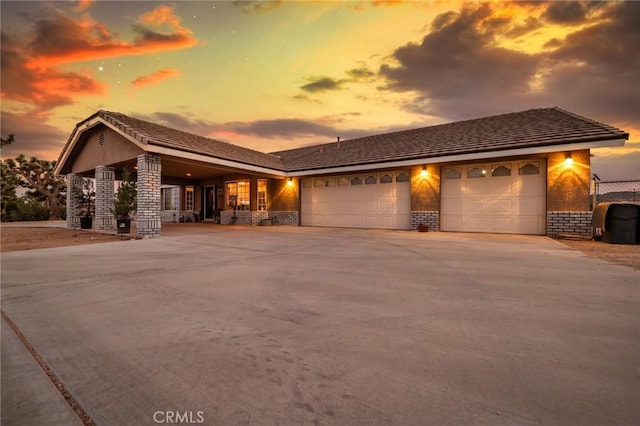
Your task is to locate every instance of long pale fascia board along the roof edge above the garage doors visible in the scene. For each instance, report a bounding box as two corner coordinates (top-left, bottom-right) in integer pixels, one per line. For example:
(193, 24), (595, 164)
(286, 139), (625, 177)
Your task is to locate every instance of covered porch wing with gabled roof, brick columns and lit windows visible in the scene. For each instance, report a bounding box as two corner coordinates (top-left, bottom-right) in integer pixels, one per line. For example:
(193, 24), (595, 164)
(56, 112), (299, 237)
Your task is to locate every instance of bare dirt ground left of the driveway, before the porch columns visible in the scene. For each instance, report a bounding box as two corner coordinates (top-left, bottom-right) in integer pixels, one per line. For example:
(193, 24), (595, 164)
(0, 226), (131, 253)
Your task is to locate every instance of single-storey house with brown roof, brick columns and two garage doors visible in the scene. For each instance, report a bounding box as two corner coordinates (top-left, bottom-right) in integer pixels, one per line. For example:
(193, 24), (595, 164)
(56, 108), (629, 236)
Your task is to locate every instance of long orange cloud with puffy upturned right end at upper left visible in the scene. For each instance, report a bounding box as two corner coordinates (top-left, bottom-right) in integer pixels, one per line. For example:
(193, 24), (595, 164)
(25, 6), (198, 69)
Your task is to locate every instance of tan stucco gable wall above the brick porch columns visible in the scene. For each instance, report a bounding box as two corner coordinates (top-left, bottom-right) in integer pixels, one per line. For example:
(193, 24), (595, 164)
(72, 126), (144, 174)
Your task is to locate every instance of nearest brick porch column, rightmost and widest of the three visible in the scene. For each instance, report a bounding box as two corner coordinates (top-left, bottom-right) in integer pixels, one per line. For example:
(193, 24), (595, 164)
(137, 153), (162, 237)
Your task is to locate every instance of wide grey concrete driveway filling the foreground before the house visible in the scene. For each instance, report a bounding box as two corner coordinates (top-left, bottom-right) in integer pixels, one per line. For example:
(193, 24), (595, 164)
(2, 224), (640, 425)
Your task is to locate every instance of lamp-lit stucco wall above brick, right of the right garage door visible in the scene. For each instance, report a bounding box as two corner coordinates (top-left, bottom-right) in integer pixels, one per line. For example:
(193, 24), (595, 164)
(547, 149), (591, 212)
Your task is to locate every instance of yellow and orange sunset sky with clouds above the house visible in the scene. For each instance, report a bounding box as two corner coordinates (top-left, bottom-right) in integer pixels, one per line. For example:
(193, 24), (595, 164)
(0, 0), (640, 180)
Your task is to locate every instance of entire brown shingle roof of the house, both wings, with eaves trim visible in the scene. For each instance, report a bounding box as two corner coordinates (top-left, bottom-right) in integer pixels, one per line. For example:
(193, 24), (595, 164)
(58, 107), (629, 176)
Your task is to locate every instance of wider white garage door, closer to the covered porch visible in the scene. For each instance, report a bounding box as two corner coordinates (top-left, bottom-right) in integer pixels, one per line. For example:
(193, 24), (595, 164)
(301, 171), (411, 229)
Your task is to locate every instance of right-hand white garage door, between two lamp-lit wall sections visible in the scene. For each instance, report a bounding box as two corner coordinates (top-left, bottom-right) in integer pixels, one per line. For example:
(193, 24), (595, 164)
(440, 159), (547, 235)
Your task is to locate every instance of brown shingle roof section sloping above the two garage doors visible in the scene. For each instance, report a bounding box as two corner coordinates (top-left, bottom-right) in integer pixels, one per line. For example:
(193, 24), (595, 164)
(273, 107), (629, 171)
